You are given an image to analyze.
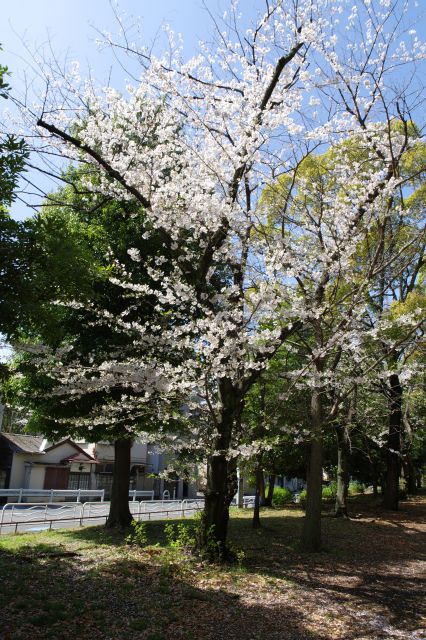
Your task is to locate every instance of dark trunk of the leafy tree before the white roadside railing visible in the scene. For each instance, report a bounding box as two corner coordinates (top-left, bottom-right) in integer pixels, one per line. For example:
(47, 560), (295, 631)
(106, 438), (133, 529)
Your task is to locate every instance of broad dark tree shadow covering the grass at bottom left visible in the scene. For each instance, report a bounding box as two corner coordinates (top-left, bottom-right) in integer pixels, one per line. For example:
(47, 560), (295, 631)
(0, 543), (327, 640)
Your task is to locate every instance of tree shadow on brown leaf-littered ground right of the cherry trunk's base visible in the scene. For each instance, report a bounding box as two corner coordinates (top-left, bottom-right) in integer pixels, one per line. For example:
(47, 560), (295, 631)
(231, 505), (426, 637)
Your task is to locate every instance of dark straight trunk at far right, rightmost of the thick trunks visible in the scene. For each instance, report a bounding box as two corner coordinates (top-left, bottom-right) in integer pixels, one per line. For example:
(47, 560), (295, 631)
(383, 373), (402, 511)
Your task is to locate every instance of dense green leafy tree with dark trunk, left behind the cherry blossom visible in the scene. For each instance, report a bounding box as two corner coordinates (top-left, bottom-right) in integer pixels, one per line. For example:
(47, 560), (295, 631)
(6, 168), (183, 527)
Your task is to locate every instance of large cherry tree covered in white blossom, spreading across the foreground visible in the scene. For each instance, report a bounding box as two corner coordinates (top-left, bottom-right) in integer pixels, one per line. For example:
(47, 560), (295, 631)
(15, 0), (425, 554)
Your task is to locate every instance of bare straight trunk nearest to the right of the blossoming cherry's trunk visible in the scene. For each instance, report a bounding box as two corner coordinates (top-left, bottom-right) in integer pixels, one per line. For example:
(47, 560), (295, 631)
(301, 390), (322, 551)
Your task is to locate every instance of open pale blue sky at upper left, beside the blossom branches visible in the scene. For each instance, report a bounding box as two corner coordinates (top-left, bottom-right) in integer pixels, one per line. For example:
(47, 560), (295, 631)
(0, 0), (240, 219)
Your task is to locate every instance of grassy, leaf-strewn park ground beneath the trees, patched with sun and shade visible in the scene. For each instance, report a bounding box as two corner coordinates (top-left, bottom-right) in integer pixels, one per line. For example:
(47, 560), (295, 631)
(0, 496), (426, 640)
